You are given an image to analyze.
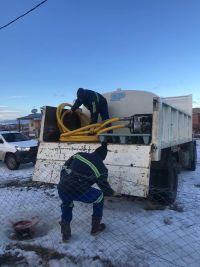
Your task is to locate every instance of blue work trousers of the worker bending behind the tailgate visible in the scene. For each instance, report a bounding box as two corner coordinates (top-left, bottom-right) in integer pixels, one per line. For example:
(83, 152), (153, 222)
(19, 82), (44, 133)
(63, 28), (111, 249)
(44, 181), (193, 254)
(58, 187), (104, 223)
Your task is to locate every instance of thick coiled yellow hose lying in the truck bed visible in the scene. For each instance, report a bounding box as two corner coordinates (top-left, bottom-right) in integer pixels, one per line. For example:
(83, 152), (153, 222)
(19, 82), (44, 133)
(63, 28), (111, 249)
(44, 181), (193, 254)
(56, 103), (125, 142)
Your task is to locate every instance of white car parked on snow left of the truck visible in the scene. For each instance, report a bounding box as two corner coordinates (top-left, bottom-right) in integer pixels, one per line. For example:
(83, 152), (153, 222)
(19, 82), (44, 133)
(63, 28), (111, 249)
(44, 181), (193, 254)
(0, 131), (38, 170)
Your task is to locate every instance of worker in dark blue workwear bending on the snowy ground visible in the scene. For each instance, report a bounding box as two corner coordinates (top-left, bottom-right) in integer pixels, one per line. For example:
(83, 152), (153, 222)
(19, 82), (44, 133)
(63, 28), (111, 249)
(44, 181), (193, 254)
(58, 142), (115, 241)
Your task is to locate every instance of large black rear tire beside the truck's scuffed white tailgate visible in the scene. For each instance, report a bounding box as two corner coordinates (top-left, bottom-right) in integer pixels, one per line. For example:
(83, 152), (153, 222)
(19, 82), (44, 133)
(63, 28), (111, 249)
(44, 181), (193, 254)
(149, 154), (178, 205)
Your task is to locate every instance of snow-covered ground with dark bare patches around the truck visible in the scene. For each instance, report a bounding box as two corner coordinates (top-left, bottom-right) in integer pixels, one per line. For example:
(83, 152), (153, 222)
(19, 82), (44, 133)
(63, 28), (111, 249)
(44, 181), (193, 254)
(0, 141), (200, 267)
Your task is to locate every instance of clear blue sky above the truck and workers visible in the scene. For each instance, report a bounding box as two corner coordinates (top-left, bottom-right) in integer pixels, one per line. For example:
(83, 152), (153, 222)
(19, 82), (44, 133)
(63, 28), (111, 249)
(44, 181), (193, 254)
(0, 0), (200, 120)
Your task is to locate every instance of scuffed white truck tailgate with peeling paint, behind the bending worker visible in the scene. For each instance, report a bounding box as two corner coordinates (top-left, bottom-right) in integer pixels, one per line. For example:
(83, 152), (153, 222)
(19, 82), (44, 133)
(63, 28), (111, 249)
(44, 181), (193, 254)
(33, 143), (151, 197)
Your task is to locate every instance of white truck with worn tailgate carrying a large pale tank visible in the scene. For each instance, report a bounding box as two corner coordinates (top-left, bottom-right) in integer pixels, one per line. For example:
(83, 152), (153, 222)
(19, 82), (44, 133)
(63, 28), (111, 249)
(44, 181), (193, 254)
(33, 89), (197, 205)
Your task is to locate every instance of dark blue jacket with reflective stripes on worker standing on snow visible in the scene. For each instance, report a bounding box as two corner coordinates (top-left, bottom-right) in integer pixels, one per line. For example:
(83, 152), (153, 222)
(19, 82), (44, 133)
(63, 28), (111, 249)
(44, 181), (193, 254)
(58, 152), (113, 196)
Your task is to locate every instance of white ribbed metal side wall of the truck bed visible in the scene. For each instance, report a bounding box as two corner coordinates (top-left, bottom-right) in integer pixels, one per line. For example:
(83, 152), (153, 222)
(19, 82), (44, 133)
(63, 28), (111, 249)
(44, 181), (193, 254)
(152, 98), (192, 161)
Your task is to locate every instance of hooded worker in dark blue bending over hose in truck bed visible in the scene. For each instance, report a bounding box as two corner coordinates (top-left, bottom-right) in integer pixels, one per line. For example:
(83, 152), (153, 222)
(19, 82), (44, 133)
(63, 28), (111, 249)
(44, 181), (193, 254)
(71, 88), (109, 124)
